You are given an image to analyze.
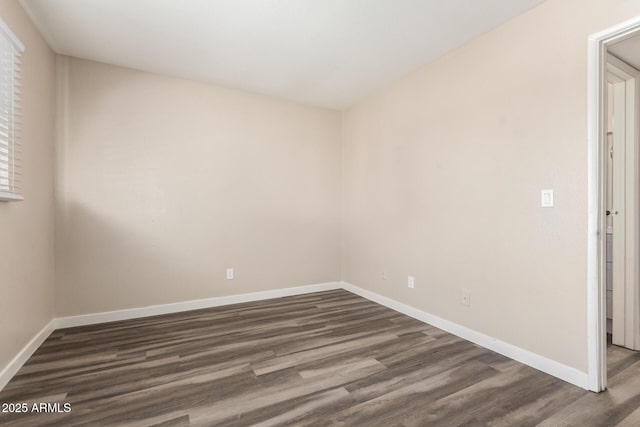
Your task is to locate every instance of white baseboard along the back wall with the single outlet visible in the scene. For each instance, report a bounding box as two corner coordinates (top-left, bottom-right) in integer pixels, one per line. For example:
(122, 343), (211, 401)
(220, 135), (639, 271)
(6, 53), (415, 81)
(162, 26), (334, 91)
(55, 282), (341, 329)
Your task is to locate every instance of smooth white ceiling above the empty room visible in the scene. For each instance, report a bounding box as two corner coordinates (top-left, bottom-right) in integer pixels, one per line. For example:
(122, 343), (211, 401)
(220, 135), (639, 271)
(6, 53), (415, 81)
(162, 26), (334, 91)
(21, 0), (543, 109)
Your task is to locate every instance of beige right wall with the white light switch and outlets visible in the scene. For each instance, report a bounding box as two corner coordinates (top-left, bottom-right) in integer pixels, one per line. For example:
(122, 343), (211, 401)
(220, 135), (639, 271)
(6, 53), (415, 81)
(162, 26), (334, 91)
(342, 0), (640, 371)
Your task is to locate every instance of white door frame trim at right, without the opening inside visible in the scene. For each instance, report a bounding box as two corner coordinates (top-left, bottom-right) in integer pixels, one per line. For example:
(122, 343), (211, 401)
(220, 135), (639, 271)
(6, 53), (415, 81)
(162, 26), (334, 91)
(587, 16), (640, 392)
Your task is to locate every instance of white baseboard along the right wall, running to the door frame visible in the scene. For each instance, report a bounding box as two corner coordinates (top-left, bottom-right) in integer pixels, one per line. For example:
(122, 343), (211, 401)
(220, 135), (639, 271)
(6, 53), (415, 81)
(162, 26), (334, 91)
(342, 282), (589, 390)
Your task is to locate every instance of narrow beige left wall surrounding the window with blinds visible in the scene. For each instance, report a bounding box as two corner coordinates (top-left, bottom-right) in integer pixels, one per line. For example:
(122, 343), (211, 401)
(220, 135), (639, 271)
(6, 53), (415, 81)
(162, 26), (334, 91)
(0, 0), (55, 371)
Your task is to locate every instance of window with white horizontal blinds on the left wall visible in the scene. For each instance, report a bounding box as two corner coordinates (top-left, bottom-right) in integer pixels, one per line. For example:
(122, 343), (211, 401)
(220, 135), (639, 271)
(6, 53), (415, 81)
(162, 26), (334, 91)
(0, 20), (24, 201)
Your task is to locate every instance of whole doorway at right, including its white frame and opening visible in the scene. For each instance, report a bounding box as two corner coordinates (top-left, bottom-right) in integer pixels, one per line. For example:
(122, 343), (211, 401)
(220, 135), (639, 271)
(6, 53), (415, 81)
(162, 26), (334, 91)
(587, 17), (640, 391)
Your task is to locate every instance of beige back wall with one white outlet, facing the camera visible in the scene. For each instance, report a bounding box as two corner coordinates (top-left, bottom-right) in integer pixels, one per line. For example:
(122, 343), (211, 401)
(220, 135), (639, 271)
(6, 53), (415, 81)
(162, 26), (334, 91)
(56, 58), (340, 316)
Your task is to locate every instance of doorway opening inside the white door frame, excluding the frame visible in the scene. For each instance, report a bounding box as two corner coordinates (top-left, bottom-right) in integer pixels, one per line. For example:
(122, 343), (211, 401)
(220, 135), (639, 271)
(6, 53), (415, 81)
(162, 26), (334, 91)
(604, 54), (640, 350)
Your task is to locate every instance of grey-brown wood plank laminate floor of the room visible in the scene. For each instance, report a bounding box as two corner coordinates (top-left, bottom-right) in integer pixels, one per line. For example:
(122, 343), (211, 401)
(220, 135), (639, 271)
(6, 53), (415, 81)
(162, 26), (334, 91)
(0, 290), (640, 427)
